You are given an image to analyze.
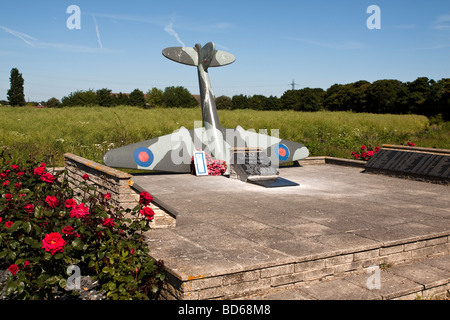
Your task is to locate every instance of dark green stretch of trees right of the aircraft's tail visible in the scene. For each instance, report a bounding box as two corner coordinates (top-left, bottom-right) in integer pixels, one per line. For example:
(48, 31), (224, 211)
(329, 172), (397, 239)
(216, 77), (450, 120)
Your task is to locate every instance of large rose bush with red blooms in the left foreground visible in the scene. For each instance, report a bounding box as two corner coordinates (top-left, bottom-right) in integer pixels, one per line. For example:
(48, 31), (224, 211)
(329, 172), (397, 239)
(0, 149), (165, 299)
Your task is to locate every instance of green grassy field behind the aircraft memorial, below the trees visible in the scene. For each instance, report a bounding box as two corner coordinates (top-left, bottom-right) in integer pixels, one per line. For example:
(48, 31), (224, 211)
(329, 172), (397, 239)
(0, 106), (450, 166)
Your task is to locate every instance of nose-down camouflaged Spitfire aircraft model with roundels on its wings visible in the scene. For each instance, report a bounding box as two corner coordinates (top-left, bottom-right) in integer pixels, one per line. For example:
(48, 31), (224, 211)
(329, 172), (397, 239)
(103, 42), (309, 174)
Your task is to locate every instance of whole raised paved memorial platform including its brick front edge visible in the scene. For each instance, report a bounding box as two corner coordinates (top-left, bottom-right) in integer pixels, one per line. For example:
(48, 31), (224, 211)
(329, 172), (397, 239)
(132, 164), (450, 300)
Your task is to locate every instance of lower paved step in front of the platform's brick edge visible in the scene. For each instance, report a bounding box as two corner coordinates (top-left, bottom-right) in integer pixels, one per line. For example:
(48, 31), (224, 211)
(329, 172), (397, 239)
(243, 255), (450, 300)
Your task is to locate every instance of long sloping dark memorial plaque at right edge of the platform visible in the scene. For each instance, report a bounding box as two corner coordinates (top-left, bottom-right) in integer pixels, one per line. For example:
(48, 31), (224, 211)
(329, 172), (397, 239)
(365, 149), (450, 183)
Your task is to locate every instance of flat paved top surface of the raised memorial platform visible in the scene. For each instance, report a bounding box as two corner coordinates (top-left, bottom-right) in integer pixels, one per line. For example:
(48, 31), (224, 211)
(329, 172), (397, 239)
(132, 164), (450, 300)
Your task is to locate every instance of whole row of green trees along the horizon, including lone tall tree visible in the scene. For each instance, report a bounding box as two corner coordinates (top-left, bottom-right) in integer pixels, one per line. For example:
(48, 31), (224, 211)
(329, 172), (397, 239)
(0, 68), (450, 121)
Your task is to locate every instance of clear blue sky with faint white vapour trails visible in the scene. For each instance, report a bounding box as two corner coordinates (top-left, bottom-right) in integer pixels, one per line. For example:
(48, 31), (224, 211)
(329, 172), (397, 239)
(0, 0), (450, 101)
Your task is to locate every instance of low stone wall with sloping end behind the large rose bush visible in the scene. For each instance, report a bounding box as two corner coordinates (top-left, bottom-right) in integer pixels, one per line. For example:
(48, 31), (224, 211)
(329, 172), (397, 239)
(64, 153), (176, 229)
